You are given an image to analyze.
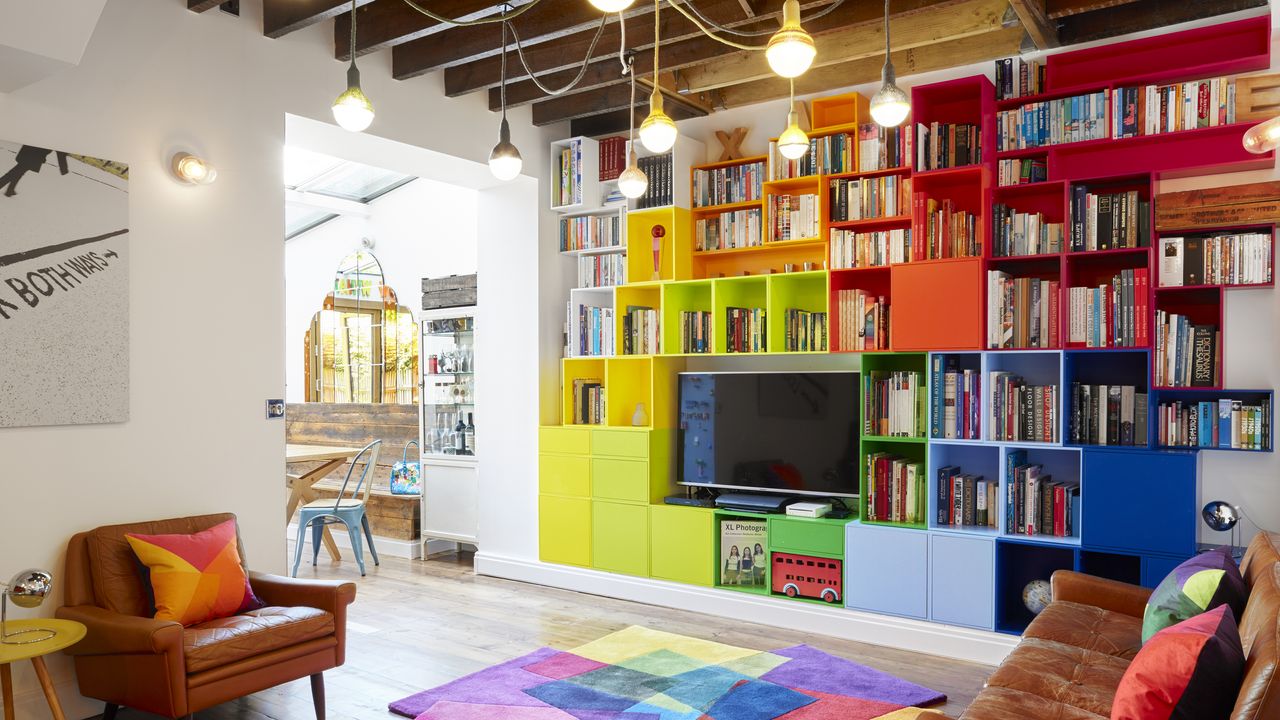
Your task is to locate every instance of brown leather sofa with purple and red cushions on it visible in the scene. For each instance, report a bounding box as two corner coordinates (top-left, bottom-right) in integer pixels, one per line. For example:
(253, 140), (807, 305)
(920, 533), (1280, 720)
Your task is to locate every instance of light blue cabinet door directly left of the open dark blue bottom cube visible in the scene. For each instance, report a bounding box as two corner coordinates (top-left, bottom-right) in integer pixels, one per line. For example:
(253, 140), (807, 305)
(929, 534), (996, 630)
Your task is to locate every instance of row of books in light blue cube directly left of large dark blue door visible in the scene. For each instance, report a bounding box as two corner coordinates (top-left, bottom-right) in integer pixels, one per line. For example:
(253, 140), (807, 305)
(1005, 450), (1080, 538)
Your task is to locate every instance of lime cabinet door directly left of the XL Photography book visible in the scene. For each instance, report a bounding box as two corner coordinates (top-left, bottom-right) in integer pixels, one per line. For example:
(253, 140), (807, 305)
(649, 505), (716, 587)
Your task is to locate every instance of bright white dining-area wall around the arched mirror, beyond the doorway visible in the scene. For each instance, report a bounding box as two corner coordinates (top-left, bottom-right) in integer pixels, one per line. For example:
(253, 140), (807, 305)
(284, 178), (477, 402)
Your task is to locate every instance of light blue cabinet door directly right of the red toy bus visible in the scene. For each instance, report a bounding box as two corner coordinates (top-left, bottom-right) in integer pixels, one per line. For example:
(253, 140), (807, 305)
(845, 523), (929, 620)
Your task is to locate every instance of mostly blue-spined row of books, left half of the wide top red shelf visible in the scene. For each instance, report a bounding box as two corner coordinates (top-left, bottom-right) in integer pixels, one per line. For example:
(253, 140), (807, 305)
(996, 90), (1110, 151)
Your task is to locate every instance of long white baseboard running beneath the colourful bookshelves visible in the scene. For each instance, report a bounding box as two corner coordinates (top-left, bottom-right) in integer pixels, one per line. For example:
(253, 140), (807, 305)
(475, 551), (1018, 665)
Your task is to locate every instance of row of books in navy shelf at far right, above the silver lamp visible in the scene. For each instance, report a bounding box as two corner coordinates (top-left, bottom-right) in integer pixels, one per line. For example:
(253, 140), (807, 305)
(1156, 397), (1271, 450)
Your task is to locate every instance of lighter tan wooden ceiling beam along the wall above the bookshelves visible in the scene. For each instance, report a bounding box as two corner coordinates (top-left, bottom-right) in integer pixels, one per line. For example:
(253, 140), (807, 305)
(681, 0), (1009, 92)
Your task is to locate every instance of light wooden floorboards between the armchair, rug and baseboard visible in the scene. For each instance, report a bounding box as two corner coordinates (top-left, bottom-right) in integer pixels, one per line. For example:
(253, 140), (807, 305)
(118, 545), (992, 720)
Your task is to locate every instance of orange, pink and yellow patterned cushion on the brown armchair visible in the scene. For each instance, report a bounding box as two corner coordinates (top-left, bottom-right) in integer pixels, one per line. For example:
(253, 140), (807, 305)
(124, 520), (262, 625)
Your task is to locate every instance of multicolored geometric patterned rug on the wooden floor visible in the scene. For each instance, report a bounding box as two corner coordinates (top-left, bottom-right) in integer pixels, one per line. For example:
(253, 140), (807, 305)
(390, 626), (946, 720)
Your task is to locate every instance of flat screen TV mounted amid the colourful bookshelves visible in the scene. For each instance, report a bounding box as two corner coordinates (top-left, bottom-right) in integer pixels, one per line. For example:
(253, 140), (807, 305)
(676, 372), (859, 497)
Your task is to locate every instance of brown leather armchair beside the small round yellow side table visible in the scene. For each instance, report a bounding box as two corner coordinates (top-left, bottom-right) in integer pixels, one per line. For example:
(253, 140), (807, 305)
(58, 514), (356, 720)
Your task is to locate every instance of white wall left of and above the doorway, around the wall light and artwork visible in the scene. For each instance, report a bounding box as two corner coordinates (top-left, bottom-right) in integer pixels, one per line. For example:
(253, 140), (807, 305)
(0, 0), (566, 717)
